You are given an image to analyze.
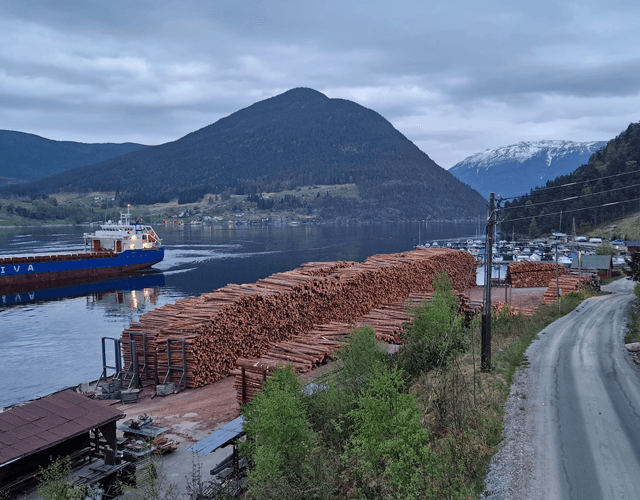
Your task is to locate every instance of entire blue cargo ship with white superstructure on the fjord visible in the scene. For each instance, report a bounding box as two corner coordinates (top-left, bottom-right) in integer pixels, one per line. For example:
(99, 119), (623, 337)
(0, 210), (164, 293)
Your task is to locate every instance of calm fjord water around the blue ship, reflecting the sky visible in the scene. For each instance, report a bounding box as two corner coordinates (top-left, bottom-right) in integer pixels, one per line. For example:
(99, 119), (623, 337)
(0, 223), (478, 408)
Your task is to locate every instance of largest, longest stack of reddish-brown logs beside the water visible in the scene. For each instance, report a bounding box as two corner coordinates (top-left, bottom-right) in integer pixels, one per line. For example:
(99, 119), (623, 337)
(122, 249), (477, 387)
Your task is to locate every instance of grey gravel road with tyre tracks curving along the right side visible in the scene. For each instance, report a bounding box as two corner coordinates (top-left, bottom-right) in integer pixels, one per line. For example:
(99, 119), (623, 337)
(485, 279), (640, 500)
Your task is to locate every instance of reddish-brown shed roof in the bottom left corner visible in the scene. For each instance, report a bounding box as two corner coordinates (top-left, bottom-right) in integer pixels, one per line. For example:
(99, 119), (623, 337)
(0, 391), (124, 466)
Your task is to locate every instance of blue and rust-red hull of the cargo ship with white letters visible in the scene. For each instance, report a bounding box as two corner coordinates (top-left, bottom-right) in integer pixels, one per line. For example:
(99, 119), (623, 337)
(0, 248), (164, 291)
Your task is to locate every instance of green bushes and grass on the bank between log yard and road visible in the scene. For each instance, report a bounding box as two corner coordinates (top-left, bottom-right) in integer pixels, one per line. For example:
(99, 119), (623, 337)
(242, 274), (593, 499)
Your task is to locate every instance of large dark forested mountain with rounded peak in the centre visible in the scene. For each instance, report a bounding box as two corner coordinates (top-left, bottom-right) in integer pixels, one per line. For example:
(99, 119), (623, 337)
(5, 88), (486, 220)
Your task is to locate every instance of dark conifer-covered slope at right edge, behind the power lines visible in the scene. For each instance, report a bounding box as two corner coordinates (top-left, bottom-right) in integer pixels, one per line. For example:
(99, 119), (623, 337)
(501, 123), (640, 236)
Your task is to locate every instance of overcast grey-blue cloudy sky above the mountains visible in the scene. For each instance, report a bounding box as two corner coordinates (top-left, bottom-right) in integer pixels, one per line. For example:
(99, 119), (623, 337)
(0, 0), (640, 168)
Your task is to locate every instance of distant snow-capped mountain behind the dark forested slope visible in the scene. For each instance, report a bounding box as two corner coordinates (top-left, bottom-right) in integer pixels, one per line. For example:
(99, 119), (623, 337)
(449, 141), (607, 198)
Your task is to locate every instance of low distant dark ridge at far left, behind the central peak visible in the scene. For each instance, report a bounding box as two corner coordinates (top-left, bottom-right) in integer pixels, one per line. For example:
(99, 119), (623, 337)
(0, 130), (147, 185)
